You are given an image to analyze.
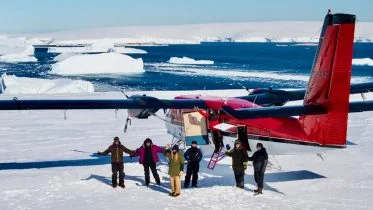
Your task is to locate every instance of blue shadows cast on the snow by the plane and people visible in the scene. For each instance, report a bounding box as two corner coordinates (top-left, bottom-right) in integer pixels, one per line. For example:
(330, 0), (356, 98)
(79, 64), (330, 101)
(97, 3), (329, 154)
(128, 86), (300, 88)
(0, 151), (326, 194)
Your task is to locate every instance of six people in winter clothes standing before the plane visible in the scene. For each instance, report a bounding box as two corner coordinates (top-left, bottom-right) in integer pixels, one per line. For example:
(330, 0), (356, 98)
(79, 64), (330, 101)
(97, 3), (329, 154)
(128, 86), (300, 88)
(98, 137), (268, 197)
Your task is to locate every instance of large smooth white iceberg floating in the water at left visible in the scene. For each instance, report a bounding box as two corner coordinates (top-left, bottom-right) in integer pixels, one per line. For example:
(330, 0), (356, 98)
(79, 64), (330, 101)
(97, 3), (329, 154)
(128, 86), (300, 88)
(50, 52), (144, 75)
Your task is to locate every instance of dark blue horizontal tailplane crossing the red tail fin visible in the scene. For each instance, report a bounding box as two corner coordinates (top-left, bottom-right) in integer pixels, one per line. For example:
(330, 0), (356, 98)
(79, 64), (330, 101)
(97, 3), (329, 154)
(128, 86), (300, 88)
(222, 101), (373, 120)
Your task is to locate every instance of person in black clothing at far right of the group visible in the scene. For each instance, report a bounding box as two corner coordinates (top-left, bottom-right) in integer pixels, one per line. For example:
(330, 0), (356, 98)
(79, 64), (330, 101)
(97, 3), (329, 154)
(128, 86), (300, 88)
(249, 143), (268, 194)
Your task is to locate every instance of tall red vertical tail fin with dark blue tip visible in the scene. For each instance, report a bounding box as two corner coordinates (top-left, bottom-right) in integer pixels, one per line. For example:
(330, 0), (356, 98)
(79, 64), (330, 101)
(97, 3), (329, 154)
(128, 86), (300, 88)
(300, 14), (355, 146)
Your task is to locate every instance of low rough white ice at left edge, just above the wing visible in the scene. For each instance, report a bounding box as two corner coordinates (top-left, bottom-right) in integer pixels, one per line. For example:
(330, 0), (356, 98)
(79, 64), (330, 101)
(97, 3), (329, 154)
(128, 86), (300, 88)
(0, 74), (94, 95)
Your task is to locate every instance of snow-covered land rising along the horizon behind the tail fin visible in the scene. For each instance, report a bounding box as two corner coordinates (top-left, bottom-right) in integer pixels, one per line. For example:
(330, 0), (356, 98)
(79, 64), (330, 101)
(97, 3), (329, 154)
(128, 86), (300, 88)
(22, 21), (373, 45)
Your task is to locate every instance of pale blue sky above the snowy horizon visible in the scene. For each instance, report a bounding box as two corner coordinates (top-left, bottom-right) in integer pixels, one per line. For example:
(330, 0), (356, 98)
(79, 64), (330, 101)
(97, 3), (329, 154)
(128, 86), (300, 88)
(0, 0), (373, 34)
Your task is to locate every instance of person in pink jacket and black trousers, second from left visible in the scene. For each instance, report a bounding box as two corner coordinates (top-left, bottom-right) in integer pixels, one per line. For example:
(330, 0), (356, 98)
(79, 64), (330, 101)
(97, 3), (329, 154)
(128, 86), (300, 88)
(133, 138), (164, 186)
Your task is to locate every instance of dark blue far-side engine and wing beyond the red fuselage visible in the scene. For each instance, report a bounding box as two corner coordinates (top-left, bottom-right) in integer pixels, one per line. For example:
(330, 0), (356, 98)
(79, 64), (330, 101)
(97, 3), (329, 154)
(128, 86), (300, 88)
(237, 82), (373, 106)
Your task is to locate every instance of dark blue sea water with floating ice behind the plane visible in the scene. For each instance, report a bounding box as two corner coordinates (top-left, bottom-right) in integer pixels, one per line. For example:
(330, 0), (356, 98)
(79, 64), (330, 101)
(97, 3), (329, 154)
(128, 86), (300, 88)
(0, 43), (373, 91)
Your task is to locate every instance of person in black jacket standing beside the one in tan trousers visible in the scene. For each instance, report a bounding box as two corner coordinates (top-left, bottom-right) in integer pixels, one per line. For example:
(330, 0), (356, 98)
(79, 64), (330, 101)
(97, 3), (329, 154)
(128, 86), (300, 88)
(184, 141), (202, 188)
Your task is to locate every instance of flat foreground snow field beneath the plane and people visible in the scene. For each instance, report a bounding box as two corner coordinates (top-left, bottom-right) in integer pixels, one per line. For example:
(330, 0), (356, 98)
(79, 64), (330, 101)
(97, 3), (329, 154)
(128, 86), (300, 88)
(0, 90), (373, 210)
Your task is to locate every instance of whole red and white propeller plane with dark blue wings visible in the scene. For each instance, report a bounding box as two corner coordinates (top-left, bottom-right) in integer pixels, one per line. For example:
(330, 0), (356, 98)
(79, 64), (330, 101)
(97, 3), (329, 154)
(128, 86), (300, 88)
(0, 14), (373, 168)
